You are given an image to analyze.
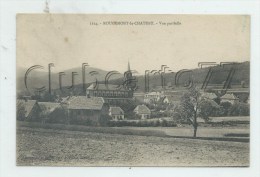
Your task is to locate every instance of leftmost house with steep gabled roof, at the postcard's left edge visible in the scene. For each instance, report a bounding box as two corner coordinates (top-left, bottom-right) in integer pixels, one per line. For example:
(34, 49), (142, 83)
(16, 99), (40, 121)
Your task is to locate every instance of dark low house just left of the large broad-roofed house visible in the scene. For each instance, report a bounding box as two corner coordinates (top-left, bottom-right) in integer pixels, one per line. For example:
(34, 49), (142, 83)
(38, 102), (66, 123)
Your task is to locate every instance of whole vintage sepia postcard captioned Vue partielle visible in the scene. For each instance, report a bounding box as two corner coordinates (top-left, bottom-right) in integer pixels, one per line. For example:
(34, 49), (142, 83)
(16, 14), (250, 167)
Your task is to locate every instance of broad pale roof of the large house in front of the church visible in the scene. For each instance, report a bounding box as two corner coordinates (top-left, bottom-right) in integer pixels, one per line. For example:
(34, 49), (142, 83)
(66, 96), (104, 110)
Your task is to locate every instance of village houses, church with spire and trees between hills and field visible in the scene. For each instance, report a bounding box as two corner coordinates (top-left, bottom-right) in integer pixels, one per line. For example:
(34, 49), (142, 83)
(17, 63), (250, 126)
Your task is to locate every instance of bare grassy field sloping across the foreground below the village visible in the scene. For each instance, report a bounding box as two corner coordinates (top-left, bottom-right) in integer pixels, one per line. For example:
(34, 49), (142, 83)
(17, 127), (249, 166)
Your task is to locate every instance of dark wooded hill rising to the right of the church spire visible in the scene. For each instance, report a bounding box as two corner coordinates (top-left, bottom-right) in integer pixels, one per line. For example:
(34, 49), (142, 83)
(107, 62), (250, 92)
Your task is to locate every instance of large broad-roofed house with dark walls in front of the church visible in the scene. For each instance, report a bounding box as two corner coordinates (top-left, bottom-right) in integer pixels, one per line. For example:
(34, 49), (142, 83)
(62, 96), (109, 125)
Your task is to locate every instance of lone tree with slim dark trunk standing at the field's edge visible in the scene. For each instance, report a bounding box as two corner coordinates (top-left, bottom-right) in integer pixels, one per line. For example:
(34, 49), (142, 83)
(176, 86), (218, 138)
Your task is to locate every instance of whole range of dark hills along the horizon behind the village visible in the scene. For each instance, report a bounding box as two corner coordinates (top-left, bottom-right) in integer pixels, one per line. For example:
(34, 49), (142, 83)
(17, 62), (250, 96)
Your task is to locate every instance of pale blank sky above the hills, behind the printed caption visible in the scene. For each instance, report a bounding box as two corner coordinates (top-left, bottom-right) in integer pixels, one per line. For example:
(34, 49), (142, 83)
(17, 14), (250, 74)
